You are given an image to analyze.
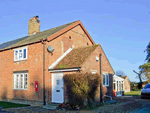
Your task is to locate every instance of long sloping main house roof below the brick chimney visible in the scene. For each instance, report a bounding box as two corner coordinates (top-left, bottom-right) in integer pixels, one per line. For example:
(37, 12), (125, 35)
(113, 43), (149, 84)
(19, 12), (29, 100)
(0, 21), (77, 49)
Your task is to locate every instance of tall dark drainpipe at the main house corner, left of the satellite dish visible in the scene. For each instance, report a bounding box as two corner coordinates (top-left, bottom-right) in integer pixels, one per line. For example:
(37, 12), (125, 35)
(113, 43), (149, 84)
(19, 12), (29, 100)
(42, 40), (46, 105)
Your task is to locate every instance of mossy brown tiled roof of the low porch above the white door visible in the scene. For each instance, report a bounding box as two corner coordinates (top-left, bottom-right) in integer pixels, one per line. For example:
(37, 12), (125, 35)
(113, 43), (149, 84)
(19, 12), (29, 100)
(53, 44), (99, 69)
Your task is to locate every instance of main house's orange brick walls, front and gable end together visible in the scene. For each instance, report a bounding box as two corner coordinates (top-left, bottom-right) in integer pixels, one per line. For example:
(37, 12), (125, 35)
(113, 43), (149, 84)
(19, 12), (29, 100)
(0, 25), (92, 101)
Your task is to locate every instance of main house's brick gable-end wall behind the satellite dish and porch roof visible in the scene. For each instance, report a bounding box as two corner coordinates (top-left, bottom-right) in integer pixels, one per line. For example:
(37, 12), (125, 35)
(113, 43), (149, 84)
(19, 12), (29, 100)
(45, 26), (92, 100)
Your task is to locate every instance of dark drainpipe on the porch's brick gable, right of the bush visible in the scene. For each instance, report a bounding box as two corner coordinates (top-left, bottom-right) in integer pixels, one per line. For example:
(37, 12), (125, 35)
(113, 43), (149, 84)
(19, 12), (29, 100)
(99, 54), (103, 102)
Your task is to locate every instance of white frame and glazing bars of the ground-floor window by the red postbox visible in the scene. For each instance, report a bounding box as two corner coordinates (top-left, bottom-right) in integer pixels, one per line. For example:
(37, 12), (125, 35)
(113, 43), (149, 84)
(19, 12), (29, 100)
(13, 72), (29, 90)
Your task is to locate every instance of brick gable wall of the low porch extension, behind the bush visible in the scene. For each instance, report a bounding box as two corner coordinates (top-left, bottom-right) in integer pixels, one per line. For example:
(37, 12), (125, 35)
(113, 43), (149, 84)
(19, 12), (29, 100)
(82, 46), (114, 100)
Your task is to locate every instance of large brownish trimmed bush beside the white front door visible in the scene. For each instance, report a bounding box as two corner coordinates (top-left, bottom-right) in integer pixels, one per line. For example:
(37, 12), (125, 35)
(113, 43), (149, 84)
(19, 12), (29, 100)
(64, 73), (100, 106)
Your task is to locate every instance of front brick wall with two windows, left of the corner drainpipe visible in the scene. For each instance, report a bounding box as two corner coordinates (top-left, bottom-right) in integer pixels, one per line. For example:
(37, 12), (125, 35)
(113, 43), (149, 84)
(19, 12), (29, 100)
(0, 43), (43, 100)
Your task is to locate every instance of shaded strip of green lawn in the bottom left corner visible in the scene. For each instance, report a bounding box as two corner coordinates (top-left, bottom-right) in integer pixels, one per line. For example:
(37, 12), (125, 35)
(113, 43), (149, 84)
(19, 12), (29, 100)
(0, 101), (30, 108)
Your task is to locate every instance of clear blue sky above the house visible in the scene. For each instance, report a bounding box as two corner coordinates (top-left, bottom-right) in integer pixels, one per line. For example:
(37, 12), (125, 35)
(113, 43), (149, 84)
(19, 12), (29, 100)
(0, 0), (150, 82)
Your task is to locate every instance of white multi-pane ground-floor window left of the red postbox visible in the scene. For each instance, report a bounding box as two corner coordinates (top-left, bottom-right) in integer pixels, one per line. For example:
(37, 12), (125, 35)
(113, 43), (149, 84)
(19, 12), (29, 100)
(14, 72), (28, 89)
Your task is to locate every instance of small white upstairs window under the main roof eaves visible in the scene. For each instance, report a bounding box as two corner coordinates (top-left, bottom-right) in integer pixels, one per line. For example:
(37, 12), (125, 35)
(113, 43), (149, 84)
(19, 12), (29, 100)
(14, 47), (27, 61)
